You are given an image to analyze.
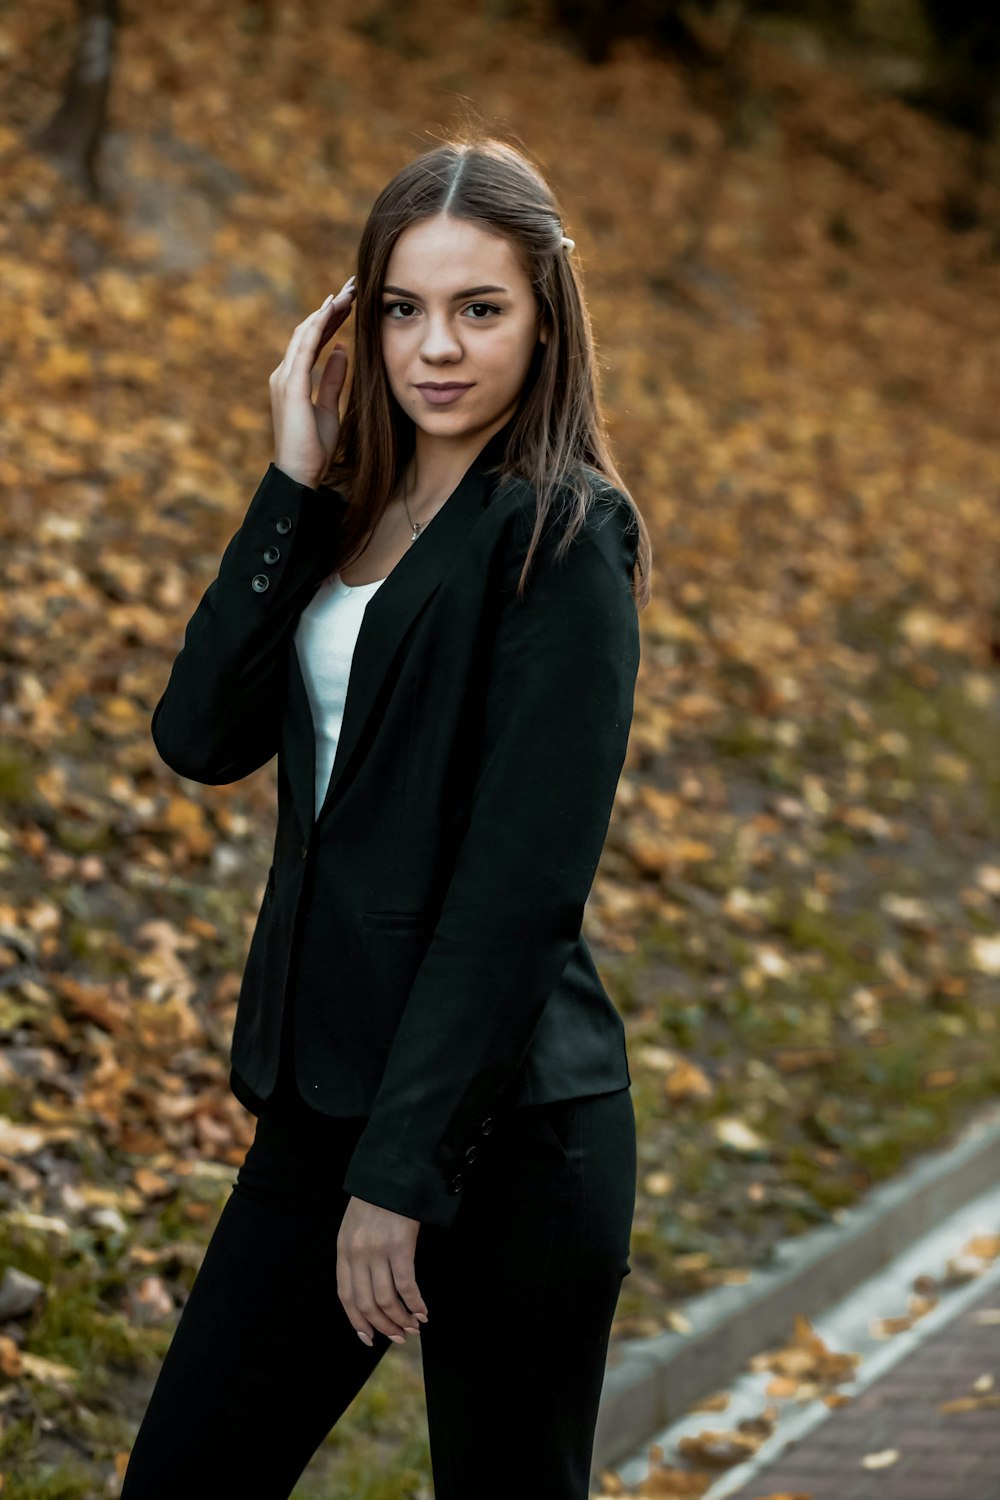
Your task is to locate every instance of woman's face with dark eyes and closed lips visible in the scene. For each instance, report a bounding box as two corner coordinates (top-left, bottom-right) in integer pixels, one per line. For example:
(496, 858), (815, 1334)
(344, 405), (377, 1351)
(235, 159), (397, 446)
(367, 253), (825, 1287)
(381, 215), (546, 437)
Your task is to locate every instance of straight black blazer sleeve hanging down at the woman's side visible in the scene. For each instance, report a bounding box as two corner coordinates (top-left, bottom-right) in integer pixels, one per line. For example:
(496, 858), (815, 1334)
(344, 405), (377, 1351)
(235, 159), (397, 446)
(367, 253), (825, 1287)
(343, 504), (639, 1226)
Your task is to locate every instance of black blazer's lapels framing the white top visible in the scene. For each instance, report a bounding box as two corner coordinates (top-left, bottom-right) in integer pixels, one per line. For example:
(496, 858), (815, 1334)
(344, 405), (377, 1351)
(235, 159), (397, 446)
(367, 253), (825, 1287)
(286, 417), (514, 834)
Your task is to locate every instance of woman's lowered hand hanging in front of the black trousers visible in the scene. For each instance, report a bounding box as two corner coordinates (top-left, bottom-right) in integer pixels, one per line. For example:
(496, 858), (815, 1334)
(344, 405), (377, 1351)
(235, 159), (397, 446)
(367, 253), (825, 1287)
(337, 1199), (427, 1346)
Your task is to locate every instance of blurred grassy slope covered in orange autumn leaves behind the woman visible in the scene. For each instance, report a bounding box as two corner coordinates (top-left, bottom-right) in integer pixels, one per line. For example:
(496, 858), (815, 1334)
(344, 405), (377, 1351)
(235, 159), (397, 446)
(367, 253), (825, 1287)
(0, 0), (1000, 1500)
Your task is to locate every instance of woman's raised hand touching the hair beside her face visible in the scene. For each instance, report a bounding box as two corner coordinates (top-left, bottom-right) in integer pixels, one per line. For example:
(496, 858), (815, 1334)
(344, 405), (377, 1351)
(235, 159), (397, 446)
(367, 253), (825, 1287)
(268, 276), (355, 489)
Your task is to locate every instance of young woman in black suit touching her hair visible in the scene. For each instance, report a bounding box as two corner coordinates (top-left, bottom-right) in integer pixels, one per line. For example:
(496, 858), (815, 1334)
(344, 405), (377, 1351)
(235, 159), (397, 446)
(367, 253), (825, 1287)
(123, 138), (649, 1500)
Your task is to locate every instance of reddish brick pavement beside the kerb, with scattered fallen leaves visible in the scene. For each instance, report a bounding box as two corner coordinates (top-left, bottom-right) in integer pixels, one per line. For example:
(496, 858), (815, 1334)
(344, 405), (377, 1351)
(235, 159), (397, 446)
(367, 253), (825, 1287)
(729, 1284), (1000, 1500)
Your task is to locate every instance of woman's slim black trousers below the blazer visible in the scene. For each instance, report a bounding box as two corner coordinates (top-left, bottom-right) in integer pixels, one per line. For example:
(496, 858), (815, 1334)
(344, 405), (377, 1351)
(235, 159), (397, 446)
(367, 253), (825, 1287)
(121, 1068), (636, 1500)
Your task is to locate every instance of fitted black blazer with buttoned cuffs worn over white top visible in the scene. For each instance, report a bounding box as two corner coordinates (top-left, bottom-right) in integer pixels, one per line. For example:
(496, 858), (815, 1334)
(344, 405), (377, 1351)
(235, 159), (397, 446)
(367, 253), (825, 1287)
(151, 423), (639, 1224)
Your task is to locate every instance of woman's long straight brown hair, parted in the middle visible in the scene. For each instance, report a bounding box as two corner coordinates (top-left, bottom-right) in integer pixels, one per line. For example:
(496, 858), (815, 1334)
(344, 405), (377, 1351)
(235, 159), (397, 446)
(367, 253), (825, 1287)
(324, 134), (652, 609)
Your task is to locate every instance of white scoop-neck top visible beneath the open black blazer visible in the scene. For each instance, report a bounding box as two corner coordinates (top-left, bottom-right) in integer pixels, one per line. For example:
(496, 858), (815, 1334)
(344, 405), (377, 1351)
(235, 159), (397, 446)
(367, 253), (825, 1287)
(295, 573), (385, 819)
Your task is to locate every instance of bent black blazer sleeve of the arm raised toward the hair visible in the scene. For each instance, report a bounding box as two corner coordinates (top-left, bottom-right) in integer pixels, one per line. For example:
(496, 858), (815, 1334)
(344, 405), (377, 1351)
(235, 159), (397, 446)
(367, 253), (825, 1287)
(150, 464), (346, 786)
